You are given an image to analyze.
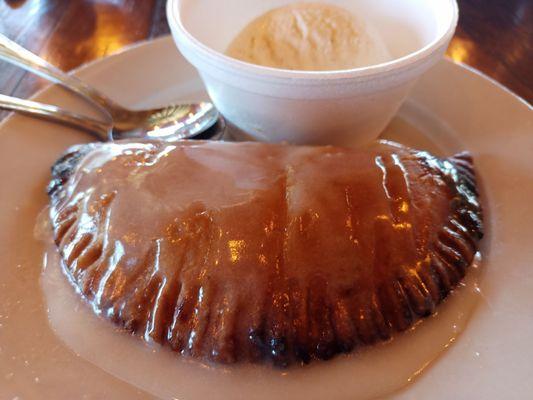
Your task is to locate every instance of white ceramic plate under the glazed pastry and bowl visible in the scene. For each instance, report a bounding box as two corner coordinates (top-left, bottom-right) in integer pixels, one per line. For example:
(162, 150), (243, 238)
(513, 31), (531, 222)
(0, 38), (533, 399)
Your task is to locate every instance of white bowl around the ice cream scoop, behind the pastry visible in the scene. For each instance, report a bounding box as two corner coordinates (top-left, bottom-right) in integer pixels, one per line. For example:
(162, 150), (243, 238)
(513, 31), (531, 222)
(167, 0), (458, 144)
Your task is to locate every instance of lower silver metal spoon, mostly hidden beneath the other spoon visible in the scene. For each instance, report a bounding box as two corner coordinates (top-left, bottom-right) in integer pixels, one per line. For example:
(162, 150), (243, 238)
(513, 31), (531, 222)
(0, 94), (225, 142)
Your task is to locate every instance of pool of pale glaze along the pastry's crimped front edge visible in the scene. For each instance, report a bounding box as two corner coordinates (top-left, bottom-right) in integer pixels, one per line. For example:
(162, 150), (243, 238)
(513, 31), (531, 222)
(41, 231), (480, 400)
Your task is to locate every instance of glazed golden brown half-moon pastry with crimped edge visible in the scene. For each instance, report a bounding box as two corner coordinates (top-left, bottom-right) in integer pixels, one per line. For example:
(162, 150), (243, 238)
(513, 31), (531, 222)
(49, 141), (482, 365)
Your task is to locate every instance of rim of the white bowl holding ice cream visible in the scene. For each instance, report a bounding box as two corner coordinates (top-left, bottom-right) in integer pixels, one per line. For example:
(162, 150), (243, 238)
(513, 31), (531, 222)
(166, 0), (459, 81)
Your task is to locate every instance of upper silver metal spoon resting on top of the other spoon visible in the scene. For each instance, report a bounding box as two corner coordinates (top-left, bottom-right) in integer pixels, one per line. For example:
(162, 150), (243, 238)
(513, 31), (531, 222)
(0, 35), (221, 140)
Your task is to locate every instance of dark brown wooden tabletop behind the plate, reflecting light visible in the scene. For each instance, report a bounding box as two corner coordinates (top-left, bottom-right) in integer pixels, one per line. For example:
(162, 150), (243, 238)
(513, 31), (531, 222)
(0, 0), (533, 109)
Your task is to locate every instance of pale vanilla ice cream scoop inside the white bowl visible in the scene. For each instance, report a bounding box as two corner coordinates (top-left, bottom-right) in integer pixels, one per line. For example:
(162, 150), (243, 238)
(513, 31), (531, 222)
(226, 3), (390, 71)
